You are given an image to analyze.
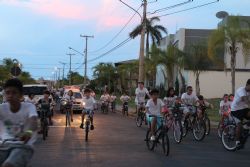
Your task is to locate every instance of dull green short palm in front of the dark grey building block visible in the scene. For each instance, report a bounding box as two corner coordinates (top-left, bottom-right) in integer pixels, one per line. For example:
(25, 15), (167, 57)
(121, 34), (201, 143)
(185, 42), (213, 95)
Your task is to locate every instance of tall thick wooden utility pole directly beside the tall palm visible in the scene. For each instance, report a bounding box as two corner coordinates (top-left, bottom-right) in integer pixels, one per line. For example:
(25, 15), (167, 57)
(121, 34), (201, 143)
(139, 0), (147, 82)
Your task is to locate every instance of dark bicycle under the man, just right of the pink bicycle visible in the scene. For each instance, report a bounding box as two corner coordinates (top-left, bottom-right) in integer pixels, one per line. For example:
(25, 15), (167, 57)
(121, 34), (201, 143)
(182, 106), (206, 141)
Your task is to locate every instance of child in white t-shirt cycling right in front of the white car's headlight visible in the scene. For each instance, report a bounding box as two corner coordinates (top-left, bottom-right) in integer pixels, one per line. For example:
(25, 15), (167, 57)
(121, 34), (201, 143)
(80, 88), (96, 130)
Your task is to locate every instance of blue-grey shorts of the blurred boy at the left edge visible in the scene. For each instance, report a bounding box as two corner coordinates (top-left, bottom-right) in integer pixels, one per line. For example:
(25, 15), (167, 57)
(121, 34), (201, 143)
(0, 146), (34, 167)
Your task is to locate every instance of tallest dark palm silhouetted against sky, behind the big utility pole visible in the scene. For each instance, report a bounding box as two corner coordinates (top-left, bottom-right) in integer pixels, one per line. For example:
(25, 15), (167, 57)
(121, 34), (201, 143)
(129, 17), (167, 57)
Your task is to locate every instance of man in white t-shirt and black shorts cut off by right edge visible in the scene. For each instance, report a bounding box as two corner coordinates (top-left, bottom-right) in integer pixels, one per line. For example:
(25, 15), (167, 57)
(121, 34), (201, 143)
(231, 79), (250, 148)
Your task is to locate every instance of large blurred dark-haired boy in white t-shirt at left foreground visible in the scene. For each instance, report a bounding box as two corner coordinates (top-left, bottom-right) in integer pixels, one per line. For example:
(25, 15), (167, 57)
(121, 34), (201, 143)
(0, 78), (37, 167)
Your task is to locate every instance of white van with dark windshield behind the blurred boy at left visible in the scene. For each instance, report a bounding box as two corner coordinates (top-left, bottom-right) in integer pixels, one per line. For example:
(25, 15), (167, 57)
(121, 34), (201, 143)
(23, 84), (48, 102)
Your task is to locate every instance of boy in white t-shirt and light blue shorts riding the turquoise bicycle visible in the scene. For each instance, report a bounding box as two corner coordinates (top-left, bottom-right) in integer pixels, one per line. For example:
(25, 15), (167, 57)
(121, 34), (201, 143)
(146, 89), (164, 141)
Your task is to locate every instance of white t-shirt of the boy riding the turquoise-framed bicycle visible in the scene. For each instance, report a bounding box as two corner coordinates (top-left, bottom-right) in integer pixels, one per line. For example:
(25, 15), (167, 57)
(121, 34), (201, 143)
(146, 99), (164, 116)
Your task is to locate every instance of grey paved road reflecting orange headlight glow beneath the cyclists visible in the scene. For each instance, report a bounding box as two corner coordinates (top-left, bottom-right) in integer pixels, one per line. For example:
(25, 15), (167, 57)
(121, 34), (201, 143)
(32, 109), (250, 167)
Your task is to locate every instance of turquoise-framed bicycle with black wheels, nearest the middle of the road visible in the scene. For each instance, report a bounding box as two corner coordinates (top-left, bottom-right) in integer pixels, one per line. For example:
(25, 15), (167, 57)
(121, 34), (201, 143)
(145, 115), (170, 156)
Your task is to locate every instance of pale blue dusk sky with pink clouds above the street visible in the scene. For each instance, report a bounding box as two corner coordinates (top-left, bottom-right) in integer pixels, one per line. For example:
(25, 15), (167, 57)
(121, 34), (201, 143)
(0, 0), (250, 79)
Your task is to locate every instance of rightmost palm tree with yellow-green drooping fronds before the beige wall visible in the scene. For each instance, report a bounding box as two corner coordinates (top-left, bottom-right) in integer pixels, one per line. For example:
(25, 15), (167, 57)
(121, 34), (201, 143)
(208, 16), (250, 93)
